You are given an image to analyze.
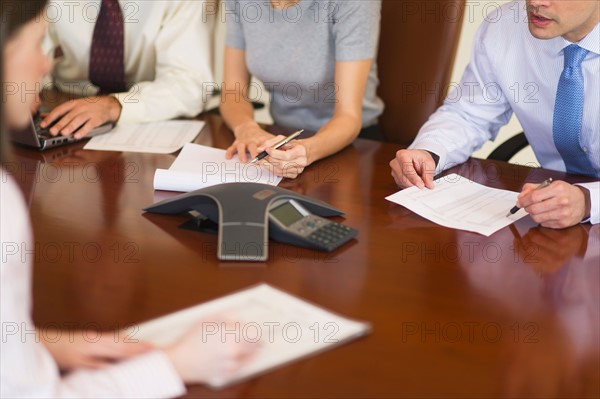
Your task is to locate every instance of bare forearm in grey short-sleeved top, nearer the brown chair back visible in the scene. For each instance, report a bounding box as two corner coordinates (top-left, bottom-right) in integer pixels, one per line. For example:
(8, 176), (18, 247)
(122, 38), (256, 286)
(302, 115), (361, 165)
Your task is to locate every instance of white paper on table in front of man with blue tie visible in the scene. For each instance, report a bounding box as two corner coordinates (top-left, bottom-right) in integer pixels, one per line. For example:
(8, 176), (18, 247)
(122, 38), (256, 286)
(386, 174), (527, 236)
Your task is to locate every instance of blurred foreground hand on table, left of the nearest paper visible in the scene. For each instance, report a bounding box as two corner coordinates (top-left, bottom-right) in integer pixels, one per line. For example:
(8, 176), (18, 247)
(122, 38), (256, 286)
(38, 329), (152, 371)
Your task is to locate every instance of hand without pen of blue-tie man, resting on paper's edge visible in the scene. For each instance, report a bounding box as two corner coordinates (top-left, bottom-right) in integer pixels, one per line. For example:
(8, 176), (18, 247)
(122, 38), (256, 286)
(390, 150), (435, 189)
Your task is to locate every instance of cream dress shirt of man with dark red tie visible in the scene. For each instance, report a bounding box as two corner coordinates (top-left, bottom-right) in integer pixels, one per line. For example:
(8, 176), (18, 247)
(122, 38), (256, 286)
(44, 0), (216, 124)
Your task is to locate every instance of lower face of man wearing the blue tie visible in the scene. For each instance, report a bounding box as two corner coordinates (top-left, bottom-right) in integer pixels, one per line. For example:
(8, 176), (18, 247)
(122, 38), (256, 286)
(526, 0), (600, 42)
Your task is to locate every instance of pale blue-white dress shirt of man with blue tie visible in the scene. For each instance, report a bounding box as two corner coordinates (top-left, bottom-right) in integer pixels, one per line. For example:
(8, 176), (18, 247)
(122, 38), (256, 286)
(410, 1), (600, 223)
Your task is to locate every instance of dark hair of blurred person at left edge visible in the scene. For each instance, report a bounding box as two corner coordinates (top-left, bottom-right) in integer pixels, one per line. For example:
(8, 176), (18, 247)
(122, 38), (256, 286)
(0, 0), (47, 164)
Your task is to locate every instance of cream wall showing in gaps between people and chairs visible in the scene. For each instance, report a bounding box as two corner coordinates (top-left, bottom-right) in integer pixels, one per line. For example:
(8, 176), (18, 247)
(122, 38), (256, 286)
(215, 0), (537, 164)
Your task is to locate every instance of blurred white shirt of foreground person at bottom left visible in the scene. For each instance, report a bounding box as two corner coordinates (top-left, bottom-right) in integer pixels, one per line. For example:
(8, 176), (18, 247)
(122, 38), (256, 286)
(0, 169), (185, 398)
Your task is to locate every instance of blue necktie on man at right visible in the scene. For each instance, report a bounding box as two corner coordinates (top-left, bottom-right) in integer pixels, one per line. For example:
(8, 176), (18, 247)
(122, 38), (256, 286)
(552, 44), (596, 176)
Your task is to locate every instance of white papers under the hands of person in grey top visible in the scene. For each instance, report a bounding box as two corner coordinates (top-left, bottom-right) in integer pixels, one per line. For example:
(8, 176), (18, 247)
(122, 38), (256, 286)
(154, 143), (282, 192)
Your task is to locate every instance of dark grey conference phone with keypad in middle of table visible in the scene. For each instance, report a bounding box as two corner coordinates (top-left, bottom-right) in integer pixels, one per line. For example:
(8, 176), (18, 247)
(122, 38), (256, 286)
(145, 183), (358, 261)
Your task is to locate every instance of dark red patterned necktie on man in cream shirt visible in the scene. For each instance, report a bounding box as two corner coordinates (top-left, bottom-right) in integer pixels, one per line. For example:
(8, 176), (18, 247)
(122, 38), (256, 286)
(89, 0), (127, 94)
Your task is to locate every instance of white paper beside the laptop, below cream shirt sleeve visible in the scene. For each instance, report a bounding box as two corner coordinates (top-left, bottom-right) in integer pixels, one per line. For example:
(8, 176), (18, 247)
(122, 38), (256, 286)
(83, 120), (204, 154)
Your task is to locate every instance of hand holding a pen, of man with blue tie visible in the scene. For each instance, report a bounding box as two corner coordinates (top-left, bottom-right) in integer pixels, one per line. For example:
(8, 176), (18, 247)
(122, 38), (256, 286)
(517, 181), (589, 229)
